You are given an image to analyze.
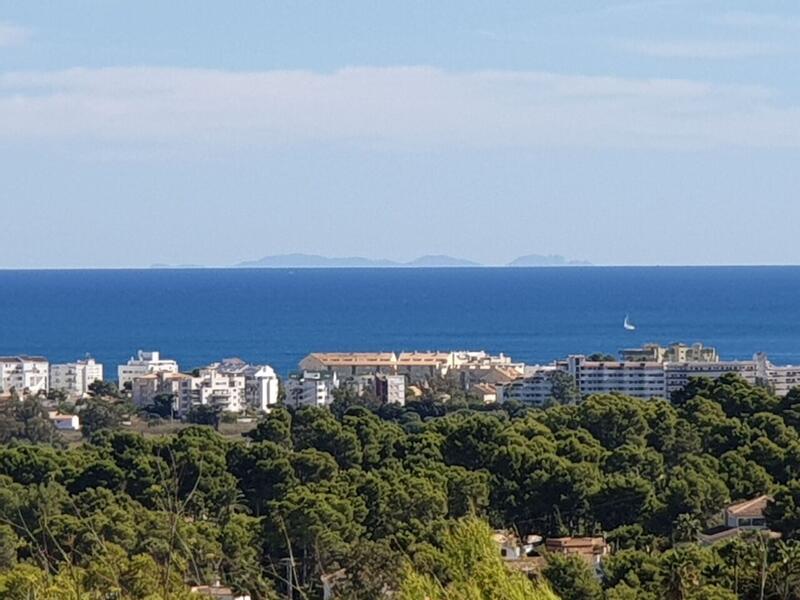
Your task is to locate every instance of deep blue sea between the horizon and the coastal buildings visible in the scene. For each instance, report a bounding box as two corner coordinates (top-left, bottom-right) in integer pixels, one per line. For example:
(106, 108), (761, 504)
(0, 267), (800, 378)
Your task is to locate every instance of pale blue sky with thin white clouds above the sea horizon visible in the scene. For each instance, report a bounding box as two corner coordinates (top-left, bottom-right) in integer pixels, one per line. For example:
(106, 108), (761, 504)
(0, 0), (800, 268)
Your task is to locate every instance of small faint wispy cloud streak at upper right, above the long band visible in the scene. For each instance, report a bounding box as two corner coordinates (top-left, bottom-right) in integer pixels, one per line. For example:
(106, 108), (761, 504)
(616, 40), (784, 60)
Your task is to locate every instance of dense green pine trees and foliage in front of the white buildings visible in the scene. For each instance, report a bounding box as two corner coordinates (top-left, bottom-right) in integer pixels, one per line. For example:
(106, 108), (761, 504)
(0, 376), (800, 600)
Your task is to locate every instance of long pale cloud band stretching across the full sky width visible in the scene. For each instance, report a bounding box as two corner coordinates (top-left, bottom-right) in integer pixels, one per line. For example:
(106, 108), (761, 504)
(0, 67), (800, 148)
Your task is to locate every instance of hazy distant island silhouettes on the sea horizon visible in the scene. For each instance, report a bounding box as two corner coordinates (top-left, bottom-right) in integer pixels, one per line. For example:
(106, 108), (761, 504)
(234, 253), (591, 269)
